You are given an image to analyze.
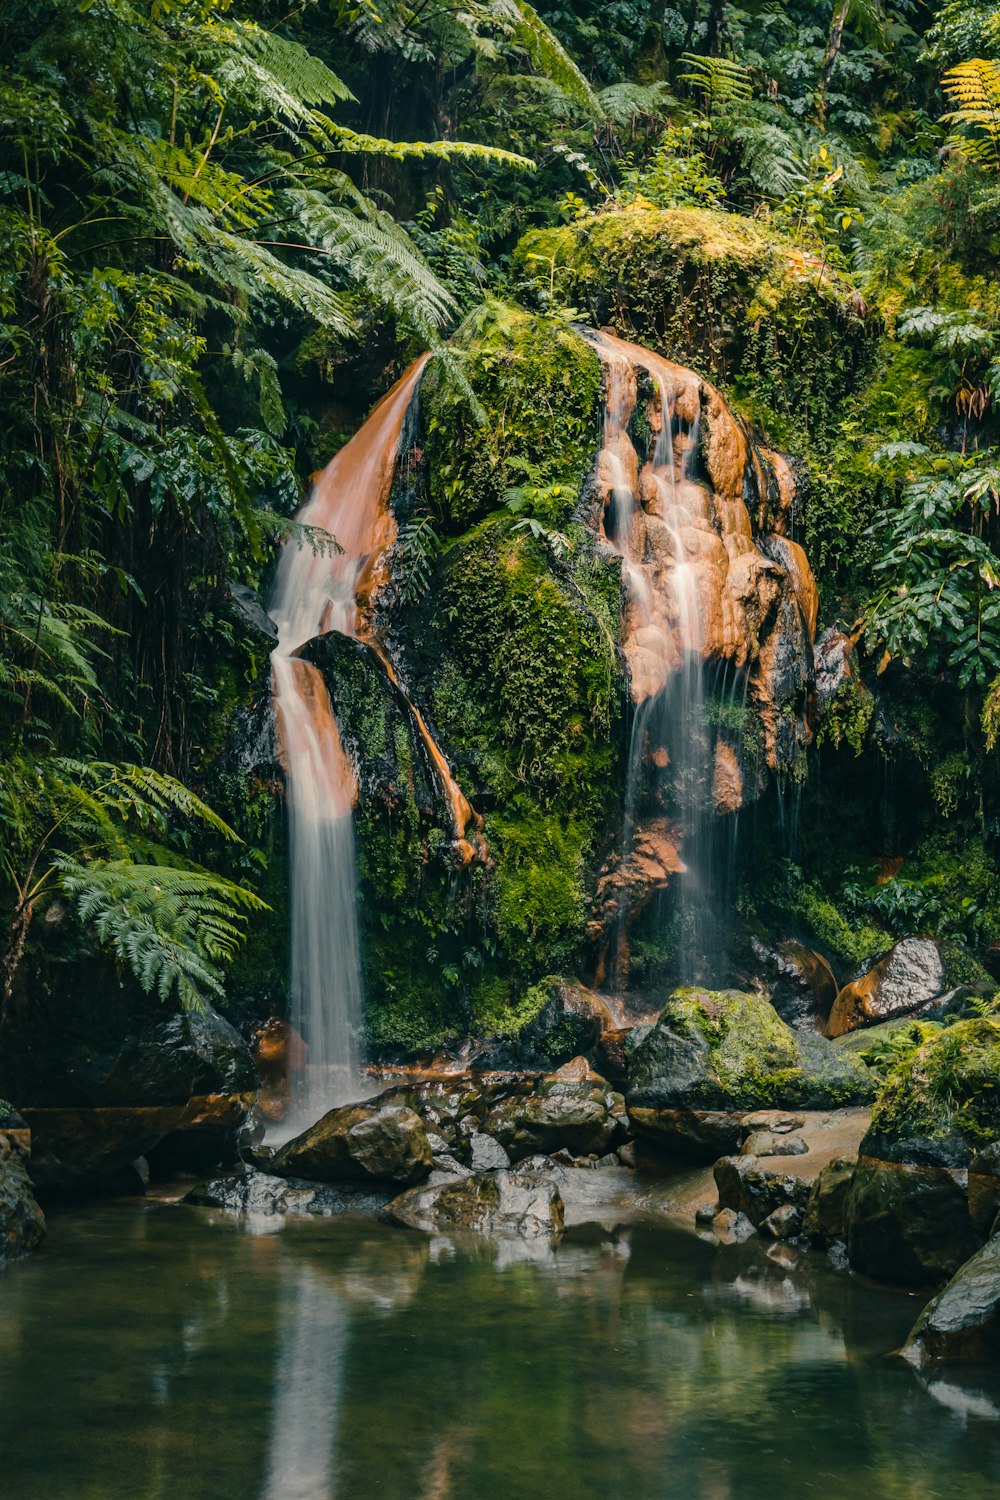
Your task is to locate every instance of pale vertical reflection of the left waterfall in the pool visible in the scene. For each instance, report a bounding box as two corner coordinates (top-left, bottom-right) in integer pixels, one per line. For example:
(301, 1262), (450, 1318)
(261, 1266), (348, 1500)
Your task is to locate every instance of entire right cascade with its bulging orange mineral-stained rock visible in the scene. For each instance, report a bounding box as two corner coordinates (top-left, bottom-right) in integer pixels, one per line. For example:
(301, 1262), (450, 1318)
(588, 332), (817, 992)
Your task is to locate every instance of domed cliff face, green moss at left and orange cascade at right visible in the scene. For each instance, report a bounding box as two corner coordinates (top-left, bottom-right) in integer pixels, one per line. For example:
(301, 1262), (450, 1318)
(296, 282), (845, 1047)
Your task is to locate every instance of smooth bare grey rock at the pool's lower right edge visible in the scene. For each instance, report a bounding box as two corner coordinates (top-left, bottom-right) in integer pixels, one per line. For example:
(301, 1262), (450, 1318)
(903, 1236), (1000, 1365)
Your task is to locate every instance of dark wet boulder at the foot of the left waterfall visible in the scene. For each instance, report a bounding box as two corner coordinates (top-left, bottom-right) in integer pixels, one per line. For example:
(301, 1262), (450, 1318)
(271, 1100), (432, 1184)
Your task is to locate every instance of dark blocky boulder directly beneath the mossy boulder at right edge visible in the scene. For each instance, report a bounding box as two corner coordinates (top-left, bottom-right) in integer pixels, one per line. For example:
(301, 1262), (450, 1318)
(846, 1155), (982, 1287)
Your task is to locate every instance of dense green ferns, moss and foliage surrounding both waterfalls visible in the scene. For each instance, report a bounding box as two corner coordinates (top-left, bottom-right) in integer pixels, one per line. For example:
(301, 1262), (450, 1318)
(0, 0), (1000, 1046)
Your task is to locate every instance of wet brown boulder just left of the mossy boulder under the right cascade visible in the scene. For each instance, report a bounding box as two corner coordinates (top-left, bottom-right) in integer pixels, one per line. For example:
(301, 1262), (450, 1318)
(483, 1074), (625, 1161)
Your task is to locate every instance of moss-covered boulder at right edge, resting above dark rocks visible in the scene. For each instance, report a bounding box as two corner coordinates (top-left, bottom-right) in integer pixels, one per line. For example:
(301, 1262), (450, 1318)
(862, 1017), (1000, 1170)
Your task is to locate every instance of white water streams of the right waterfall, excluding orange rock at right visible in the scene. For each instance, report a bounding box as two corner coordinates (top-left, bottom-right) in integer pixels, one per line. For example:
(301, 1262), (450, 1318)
(595, 335), (745, 990)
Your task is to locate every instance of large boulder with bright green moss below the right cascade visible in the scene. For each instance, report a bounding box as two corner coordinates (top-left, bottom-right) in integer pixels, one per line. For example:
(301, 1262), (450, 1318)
(627, 989), (873, 1110)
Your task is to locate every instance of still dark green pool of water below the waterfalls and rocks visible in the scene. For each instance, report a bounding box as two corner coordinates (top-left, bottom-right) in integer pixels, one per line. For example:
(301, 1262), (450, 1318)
(0, 1202), (1000, 1500)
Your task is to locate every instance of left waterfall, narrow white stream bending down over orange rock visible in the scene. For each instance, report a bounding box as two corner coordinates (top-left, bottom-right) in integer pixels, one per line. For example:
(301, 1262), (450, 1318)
(270, 360), (424, 1127)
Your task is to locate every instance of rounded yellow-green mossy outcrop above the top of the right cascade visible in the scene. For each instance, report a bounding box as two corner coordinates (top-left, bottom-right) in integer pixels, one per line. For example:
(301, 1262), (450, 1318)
(514, 203), (874, 426)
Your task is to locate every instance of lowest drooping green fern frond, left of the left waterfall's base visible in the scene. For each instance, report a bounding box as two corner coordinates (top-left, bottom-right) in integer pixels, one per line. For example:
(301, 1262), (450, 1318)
(57, 860), (268, 1010)
